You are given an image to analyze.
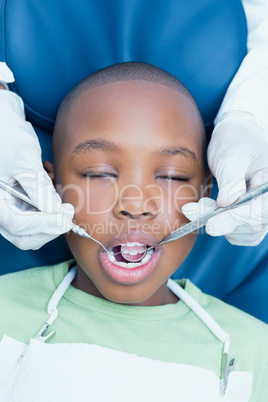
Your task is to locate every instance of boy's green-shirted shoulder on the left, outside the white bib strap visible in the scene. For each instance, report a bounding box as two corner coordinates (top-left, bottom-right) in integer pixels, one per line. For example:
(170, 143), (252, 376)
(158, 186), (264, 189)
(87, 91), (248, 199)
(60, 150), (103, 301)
(0, 261), (73, 342)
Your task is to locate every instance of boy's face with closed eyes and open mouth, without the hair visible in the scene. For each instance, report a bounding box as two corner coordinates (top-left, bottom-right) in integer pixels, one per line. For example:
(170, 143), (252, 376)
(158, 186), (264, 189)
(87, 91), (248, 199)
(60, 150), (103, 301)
(49, 81), (209, 305)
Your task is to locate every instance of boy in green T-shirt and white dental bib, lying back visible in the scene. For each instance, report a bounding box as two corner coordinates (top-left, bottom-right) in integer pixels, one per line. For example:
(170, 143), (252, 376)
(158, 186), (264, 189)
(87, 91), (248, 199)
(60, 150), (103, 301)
(0, 63), (268, 402)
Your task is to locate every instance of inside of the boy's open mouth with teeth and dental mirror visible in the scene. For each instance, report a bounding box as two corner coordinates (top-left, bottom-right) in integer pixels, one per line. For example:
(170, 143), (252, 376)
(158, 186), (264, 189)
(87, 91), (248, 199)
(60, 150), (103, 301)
(107, 242), (155, 269)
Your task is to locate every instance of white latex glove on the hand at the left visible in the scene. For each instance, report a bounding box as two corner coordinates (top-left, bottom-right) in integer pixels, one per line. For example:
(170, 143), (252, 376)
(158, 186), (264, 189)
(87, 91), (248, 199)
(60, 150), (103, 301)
(0, 63), (74, 250)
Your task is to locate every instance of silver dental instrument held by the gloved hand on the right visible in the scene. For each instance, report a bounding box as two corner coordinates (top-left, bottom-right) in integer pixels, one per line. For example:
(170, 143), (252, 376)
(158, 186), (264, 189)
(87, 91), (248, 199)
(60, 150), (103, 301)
(158, 183), (268, 245)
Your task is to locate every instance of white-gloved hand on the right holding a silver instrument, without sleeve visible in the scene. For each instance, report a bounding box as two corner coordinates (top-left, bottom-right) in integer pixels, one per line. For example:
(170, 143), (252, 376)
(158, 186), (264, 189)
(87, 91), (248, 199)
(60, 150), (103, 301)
(182, 111), (268, 246)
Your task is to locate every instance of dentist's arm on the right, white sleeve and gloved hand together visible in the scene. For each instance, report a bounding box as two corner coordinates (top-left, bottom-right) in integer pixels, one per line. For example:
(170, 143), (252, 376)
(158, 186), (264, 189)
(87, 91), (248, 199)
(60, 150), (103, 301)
(183, 0), (268, 246)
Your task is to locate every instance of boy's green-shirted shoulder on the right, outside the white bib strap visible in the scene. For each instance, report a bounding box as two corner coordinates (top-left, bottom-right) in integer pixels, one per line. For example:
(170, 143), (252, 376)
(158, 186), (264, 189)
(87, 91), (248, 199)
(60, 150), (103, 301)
(180, 280), (268, 388)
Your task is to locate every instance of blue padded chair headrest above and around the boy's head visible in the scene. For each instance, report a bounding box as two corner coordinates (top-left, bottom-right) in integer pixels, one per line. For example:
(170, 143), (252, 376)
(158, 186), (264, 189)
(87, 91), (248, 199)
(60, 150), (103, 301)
(0, 0), (247, 132)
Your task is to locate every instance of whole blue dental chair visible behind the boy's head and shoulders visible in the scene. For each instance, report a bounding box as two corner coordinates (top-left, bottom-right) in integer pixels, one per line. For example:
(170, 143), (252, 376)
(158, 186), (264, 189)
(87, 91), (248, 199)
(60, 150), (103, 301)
(0, 0), (268, 322)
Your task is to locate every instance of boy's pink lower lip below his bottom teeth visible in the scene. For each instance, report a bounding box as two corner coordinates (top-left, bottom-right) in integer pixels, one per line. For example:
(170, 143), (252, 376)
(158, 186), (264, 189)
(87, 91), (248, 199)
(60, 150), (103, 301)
(100, 251), (160, 285)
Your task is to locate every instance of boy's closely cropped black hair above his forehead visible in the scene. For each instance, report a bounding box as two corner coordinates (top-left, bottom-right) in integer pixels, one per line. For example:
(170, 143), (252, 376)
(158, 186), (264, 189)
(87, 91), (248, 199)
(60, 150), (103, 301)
(57, 62), (203, 121)
